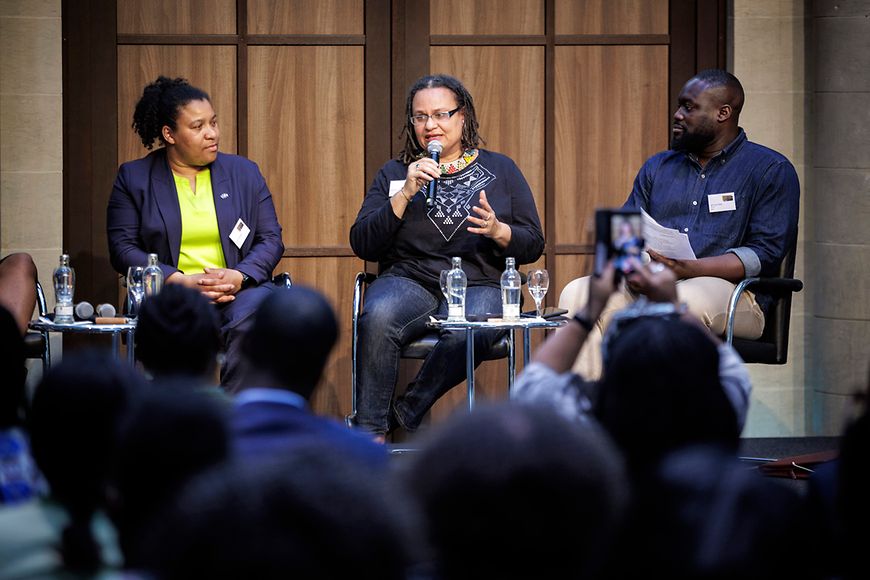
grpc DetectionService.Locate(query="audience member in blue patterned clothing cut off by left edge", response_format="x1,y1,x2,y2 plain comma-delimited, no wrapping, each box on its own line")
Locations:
0,306,45,506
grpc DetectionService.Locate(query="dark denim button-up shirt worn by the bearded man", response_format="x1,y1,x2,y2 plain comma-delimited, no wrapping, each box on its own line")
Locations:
624,129,800,277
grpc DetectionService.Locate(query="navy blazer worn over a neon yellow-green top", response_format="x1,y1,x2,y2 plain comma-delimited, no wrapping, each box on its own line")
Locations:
106,148,284,284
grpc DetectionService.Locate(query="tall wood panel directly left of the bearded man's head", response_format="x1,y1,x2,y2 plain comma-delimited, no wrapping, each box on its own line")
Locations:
554,46,669,244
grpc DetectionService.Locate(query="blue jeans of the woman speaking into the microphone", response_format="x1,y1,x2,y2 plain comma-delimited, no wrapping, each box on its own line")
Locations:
357,274,504,433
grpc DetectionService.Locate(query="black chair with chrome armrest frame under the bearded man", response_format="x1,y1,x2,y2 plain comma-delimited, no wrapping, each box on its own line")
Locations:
725,248,804,365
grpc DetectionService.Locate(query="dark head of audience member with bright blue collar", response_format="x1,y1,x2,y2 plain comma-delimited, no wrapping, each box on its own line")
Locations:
243,285,338,399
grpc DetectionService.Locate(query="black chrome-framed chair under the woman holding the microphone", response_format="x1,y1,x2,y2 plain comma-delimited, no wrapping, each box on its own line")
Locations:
345,272,513,427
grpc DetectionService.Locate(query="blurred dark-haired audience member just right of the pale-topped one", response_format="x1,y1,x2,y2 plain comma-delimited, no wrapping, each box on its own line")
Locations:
110,383,229,569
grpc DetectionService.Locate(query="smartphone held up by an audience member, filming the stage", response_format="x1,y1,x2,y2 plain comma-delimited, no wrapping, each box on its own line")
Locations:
595,209,644,278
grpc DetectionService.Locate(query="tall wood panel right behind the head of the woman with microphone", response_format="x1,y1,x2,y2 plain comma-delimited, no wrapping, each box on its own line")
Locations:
430,46,546,233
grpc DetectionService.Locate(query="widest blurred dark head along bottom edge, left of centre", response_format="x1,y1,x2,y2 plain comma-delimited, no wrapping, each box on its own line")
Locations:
144,446,414,580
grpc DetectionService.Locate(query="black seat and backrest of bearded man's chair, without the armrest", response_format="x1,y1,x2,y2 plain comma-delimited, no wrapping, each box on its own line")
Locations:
733,248,795,365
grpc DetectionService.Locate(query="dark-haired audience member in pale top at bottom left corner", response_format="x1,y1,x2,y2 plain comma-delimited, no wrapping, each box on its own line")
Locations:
0,352,143,578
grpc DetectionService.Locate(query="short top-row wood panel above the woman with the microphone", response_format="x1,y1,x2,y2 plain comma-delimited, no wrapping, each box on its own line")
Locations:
429,0,544,34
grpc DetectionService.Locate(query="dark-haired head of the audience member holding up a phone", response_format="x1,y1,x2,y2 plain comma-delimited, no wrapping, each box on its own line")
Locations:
596,316,739,474
